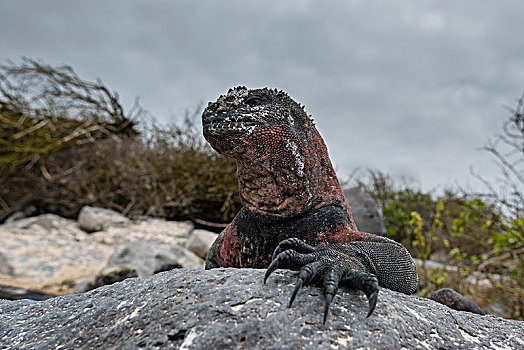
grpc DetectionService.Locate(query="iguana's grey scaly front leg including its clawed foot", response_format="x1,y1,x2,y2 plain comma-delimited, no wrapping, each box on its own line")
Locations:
264,236,418,323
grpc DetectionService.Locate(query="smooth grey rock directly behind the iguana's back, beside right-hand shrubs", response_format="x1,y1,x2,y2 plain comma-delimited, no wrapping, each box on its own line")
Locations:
344,186,386,236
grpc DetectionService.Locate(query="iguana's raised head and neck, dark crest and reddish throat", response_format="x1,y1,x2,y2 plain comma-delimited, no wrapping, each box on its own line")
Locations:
202,87,345,217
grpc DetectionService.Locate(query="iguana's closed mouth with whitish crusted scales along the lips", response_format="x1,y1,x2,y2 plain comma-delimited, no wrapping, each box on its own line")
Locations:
202,114,264,135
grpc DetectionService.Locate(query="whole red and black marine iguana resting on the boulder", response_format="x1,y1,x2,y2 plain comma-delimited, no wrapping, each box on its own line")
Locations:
202,86,418,323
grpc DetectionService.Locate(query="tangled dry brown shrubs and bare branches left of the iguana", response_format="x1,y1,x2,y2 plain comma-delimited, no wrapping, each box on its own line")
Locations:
0,59,240,222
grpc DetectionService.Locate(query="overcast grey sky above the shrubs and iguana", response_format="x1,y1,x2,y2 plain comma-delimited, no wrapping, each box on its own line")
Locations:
0,0,524,189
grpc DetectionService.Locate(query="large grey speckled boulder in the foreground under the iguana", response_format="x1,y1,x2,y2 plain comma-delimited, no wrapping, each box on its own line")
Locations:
0,269,524,349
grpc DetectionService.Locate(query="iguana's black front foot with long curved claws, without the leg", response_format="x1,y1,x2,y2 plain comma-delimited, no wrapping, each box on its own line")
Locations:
264,238,379,324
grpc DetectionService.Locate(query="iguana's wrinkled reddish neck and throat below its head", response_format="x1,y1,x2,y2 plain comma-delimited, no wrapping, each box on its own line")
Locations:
237,125,351,219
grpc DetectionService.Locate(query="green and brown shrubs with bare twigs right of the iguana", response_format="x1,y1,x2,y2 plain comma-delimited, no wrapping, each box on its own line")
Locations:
359,96,524,320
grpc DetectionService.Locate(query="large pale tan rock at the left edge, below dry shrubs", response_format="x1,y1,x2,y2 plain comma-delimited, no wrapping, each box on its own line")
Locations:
0,214,113,294
